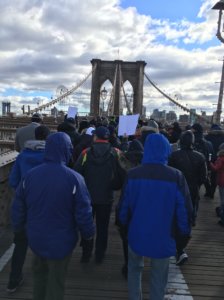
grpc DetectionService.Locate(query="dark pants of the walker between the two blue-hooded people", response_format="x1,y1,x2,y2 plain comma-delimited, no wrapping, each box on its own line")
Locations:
93,203,112,257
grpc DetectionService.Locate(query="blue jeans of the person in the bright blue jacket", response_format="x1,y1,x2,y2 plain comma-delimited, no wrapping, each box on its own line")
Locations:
128,246,169,300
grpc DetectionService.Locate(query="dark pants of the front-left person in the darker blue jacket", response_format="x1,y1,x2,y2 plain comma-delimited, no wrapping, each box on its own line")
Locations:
33,254,71,300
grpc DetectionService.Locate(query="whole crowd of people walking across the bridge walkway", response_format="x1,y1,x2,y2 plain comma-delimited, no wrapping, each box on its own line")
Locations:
7,113,224,300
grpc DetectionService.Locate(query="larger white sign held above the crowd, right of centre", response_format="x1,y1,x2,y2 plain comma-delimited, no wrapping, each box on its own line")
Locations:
118,114,139,136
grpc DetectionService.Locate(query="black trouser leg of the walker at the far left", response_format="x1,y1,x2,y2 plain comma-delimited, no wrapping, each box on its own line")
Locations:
9,231,28,282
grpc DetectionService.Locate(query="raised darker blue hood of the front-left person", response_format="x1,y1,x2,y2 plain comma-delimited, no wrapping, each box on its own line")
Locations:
44,132,73,165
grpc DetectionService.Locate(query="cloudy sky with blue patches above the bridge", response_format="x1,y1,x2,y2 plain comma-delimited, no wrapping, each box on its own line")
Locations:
0,0,224,114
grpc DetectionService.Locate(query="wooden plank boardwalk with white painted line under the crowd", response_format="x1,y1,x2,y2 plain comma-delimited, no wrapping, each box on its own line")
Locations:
0,189,224,300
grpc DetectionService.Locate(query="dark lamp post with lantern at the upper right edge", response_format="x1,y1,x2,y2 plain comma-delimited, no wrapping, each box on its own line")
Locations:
212,0,224,124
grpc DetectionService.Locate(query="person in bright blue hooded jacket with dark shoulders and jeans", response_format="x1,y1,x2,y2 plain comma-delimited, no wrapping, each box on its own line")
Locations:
119,133,192,300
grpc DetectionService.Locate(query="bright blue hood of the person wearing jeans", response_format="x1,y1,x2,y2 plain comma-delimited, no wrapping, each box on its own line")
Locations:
142,133,171,164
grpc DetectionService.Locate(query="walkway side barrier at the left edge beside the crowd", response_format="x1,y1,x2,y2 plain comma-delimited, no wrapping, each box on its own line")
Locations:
0,151,18,229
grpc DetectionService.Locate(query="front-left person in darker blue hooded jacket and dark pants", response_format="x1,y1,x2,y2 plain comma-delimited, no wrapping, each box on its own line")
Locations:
12,132,95,300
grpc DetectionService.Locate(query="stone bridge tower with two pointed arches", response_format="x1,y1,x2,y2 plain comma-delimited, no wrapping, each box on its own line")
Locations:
90,59,146,116
